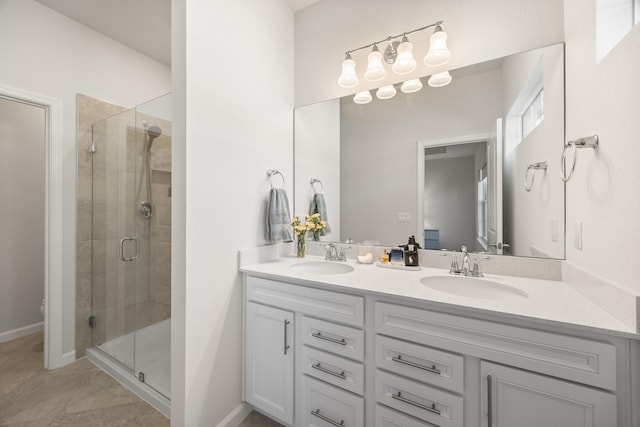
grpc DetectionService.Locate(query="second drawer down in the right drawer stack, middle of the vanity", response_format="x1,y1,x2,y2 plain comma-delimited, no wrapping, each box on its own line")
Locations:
375,370,464,427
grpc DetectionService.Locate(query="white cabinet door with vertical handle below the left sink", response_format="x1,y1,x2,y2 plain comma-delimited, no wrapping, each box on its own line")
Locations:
245,302,294,425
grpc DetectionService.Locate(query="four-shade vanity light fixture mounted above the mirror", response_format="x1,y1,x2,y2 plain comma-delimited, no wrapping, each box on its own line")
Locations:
338,21,451,89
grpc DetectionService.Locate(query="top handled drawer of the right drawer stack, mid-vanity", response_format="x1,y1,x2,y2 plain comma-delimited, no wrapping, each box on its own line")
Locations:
376,335,464,394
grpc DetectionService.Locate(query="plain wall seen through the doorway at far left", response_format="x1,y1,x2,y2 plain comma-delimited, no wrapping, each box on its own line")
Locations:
0,98,46,342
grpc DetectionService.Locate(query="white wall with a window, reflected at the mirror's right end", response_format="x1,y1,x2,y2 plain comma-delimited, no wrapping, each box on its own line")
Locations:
502,45,565,258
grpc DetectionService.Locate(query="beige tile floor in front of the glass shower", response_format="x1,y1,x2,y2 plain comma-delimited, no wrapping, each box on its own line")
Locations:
0,333,169,427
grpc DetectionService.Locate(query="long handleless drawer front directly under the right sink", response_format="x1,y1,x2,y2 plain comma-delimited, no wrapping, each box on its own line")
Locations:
375,302,616,390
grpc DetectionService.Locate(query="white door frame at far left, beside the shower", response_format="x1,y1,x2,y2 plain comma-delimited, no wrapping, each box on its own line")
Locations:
0,86,69,369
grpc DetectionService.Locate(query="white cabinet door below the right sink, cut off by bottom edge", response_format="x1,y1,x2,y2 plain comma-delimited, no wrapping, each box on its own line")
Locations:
481,362,618,427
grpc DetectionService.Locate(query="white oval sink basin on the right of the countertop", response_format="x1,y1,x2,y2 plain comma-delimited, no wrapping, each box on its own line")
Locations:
420,276,529,300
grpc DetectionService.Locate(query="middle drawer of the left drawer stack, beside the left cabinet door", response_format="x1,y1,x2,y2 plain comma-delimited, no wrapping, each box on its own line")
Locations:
302,346,364,395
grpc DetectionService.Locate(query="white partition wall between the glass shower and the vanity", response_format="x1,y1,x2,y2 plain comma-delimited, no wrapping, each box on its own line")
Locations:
172,0,293,427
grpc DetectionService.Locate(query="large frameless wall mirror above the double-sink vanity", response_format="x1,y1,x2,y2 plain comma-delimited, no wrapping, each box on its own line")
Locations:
294,44,565,259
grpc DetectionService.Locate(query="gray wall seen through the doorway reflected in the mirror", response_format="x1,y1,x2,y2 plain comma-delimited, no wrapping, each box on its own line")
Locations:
420,157,477,250
